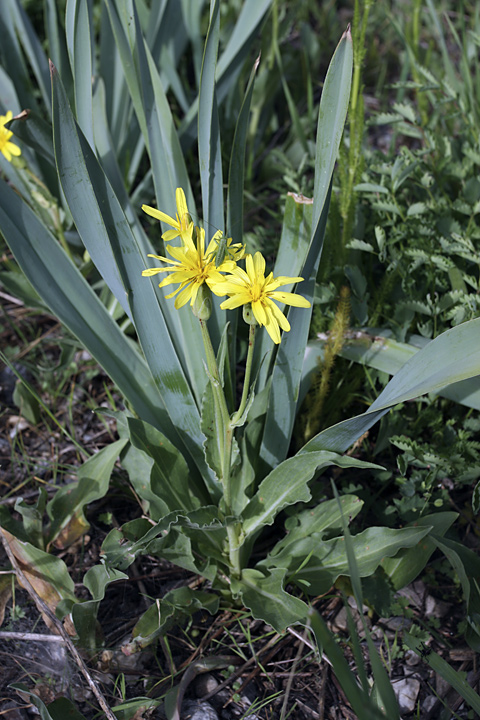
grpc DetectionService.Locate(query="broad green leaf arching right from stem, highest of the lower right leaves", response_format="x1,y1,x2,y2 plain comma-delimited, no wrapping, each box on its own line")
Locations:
242,452,378,536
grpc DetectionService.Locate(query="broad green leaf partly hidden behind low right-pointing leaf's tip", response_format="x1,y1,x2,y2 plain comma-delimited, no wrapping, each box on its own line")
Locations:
381,512,458,590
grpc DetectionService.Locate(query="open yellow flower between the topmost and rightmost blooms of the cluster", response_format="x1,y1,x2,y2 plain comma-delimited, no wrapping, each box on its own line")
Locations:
142,227,235,309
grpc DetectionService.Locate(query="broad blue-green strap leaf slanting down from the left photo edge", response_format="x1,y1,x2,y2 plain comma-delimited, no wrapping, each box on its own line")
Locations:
0,180,171,440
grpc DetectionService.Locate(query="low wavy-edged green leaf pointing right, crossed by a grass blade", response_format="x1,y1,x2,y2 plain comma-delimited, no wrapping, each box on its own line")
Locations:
289,526,431,595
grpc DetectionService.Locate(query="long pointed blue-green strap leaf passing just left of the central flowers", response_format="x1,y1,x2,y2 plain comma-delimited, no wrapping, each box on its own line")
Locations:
52,59,214,486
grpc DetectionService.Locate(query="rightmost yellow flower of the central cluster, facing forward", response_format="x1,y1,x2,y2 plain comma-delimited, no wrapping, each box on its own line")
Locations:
210,252,310,344
